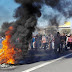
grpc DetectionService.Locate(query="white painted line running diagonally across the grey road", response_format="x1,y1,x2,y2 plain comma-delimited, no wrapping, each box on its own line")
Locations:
22,53,72,72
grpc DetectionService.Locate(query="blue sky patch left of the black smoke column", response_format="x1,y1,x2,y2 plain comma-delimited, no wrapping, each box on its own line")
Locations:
0,0,19,27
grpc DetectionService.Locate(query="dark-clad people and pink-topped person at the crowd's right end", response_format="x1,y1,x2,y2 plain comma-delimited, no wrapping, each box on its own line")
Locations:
54,32,72,52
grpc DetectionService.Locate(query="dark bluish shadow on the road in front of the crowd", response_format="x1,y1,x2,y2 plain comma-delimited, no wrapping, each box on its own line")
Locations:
16,49,71,65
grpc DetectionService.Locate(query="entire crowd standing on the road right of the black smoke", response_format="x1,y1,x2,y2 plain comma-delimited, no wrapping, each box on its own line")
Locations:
29,32,72,52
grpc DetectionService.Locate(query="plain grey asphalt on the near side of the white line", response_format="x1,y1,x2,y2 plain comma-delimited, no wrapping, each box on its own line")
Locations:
32,56,72,72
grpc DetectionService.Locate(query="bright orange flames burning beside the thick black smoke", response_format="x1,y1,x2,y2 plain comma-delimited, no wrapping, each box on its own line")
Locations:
0,26,21,64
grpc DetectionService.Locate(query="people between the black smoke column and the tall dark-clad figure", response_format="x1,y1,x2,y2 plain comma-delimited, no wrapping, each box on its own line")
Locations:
29,34,54,50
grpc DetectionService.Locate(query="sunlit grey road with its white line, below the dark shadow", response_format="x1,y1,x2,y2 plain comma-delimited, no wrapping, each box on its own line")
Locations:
0,49,72,72
